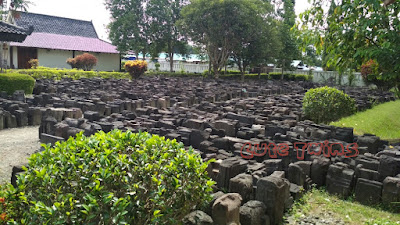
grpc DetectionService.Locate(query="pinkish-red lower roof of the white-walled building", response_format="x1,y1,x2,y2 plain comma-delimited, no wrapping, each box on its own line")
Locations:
10,33,119,54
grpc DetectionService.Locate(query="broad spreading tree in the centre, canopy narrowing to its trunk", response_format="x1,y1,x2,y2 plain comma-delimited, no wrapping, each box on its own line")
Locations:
179,0,270,78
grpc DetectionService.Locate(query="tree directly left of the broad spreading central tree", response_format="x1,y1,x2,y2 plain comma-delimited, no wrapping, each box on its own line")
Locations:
146,0,188,72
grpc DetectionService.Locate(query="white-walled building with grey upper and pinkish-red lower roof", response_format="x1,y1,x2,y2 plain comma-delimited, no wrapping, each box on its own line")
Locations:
8,12,121,71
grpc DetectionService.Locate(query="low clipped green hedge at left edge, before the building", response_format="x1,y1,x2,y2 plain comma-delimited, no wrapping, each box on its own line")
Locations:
0,73,35,95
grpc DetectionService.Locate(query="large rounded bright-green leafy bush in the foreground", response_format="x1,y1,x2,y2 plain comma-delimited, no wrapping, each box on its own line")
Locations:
9,130,214,225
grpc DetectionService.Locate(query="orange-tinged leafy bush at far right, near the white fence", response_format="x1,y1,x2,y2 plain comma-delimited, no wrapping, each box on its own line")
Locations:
361,59,396,90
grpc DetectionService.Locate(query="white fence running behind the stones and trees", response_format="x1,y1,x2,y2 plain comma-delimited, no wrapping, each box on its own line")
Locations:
148,62,366,87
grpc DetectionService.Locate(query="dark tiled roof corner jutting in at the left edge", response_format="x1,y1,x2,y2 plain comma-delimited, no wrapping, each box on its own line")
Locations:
0,21,32,42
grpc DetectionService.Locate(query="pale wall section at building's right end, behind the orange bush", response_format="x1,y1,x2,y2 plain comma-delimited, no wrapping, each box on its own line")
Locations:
75,52,120,71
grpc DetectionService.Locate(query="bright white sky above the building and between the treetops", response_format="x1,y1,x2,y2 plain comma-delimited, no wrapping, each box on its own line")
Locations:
24,0,309,40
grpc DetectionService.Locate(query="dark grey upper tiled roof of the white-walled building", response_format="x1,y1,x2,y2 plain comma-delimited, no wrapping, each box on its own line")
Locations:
15,12,98,38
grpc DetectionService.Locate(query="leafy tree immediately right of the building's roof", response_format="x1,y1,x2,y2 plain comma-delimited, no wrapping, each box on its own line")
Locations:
106,0,150,58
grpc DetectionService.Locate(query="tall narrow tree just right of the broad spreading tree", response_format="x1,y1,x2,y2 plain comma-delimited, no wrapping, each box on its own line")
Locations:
278,0,300,79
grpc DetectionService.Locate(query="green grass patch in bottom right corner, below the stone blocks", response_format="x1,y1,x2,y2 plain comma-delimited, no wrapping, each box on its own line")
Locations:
287,189,400,225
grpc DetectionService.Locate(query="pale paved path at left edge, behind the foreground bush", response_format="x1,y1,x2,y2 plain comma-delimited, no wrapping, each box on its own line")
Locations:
0,126,40,184
